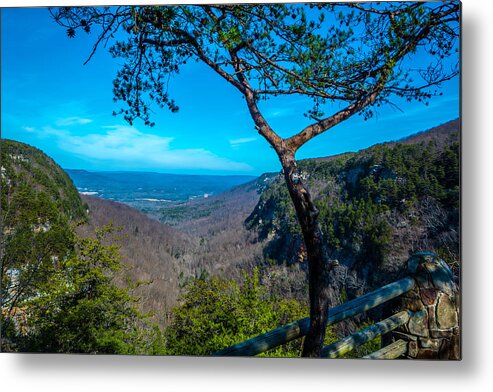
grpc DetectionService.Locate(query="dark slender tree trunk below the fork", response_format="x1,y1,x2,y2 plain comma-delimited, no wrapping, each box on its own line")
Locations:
280,153,330,357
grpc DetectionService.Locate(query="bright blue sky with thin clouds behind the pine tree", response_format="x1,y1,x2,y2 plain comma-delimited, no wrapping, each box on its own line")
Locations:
1,8,459,175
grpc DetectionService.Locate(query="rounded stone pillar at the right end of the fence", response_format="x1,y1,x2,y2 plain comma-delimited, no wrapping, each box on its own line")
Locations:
392,253,461,360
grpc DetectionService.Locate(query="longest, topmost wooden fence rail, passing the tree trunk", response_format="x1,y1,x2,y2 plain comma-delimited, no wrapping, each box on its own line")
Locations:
212,277,415,356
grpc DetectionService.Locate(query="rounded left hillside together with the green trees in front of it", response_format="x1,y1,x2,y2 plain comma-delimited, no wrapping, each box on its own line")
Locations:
0,140,160,353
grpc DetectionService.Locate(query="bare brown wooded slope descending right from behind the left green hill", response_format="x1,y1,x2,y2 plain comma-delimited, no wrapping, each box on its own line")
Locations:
77,195,192,325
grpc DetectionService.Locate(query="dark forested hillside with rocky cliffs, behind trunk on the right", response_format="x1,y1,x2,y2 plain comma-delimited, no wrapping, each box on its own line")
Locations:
246,120,460,296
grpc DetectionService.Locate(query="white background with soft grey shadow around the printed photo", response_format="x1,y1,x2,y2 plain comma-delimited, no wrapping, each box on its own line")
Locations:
0,0,493,392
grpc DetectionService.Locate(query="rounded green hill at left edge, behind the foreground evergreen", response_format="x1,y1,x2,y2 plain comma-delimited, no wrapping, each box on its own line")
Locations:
0,140,85,349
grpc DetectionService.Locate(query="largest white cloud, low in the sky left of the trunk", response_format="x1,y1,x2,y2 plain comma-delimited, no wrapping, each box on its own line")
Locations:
50,125,252,171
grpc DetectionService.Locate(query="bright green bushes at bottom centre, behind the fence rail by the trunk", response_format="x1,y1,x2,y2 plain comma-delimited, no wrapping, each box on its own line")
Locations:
166,269,333,357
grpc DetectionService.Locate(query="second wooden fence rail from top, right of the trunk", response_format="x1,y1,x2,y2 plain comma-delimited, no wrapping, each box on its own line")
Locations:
321,310,410,358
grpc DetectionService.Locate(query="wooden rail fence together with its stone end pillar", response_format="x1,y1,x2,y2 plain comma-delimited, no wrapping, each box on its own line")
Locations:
212,253,460,359
